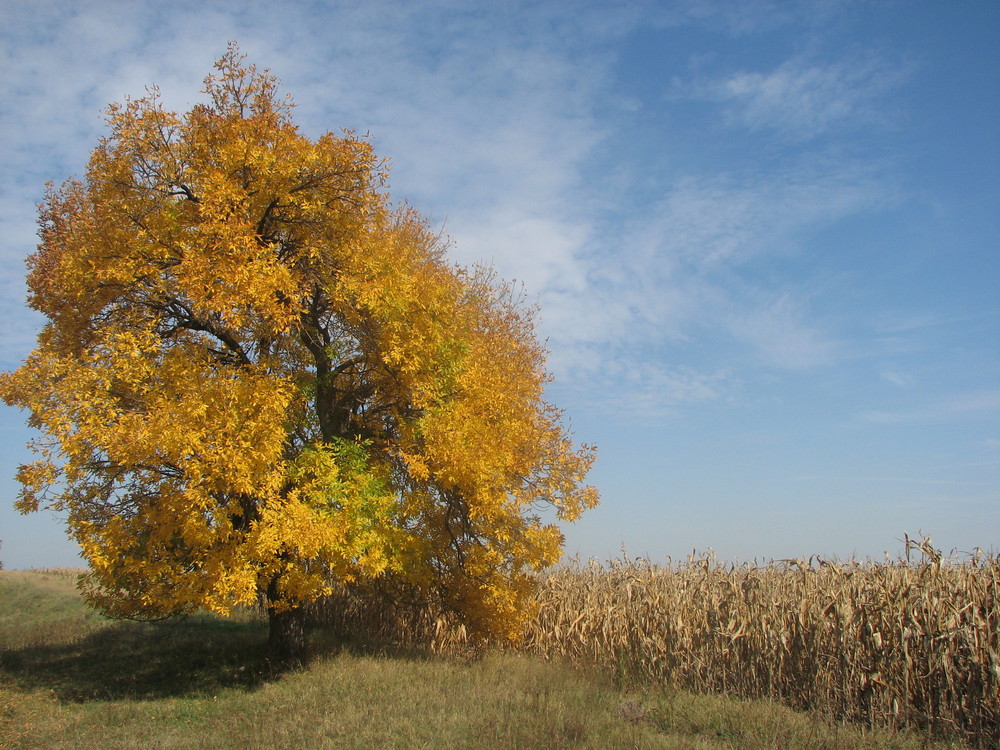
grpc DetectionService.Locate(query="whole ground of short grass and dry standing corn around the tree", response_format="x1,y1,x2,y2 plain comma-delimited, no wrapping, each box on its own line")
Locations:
0,544,1000,750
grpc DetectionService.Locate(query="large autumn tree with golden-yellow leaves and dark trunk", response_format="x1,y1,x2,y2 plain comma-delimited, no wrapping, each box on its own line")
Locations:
0,45,597,660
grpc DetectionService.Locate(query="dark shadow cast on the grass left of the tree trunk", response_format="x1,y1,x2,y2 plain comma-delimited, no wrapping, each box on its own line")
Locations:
0,614,281,702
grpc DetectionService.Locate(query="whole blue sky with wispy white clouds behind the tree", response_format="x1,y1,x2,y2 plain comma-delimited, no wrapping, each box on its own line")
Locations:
0,0,1000,569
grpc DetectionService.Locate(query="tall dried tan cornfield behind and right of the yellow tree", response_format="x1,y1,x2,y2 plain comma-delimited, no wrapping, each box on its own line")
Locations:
316,538,1000,748
